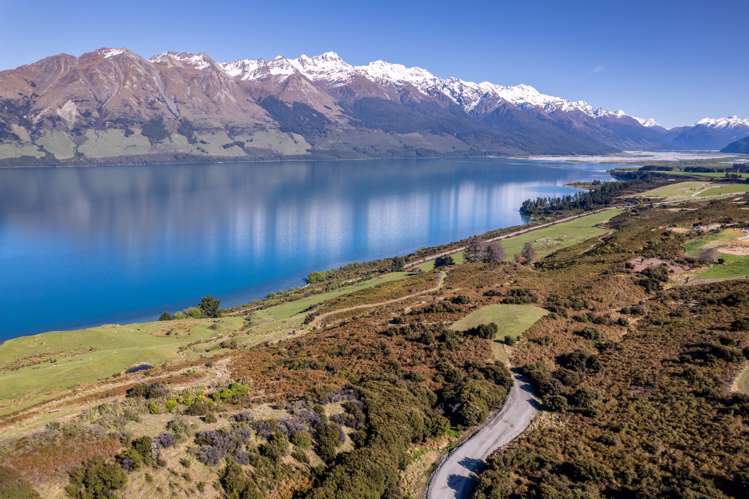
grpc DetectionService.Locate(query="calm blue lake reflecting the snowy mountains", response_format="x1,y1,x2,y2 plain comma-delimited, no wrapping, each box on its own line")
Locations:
0,159,611,341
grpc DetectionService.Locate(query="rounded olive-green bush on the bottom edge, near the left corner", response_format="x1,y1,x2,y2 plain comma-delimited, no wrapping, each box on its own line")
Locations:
65,457,127,499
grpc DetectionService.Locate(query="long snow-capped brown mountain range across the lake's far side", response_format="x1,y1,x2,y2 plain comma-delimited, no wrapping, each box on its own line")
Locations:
0,48,749,164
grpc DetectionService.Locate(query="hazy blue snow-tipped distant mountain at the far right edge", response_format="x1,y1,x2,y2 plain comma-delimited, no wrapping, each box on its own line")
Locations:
666,116,749,150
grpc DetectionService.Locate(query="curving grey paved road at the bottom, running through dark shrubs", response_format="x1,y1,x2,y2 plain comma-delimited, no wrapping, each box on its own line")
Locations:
426,374,538,499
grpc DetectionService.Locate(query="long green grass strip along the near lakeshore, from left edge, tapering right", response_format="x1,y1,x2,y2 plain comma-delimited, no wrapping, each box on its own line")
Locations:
0,272,408,415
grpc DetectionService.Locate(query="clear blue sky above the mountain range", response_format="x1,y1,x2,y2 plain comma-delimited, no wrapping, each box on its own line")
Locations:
0,0,749,126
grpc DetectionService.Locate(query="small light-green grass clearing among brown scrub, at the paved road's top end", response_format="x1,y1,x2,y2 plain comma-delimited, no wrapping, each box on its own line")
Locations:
450,305,549,362
